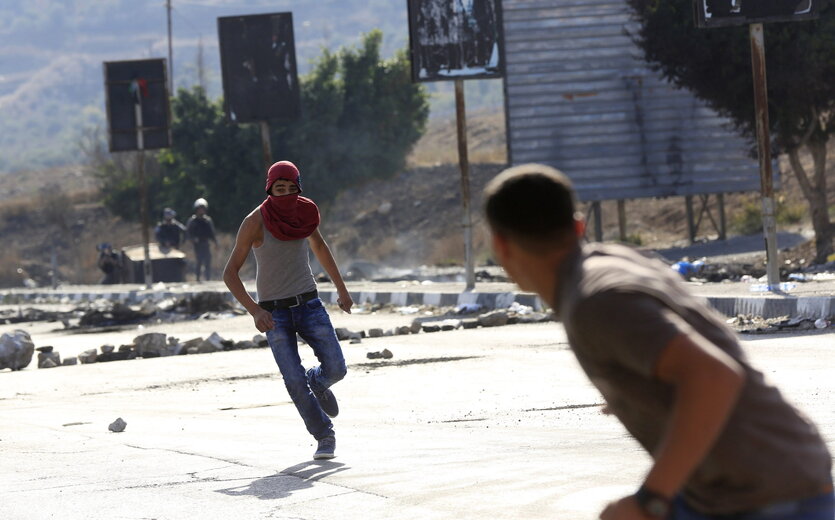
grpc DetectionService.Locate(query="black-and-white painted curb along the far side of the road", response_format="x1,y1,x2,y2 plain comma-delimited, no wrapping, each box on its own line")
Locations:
0,290,835,320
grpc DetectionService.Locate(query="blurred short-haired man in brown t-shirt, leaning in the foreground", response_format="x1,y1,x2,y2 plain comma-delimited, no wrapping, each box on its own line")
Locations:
485,164,833,520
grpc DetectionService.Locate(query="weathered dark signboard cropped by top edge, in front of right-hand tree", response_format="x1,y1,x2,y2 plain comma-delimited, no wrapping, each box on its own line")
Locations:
693,0,820,27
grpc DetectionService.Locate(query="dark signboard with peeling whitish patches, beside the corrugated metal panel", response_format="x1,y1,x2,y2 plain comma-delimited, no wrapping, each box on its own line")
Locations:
408,0,504,81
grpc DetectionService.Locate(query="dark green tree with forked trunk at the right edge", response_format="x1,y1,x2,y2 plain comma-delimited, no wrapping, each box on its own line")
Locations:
627,0,835,262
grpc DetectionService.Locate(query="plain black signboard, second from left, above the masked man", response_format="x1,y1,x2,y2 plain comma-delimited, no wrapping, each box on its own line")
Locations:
217,13,299,123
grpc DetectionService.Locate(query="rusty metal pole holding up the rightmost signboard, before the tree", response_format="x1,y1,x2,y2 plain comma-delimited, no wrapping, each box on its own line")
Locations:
748,23,780,291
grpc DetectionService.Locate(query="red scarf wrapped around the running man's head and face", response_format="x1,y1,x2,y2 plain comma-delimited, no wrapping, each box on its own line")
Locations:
261,161,319,240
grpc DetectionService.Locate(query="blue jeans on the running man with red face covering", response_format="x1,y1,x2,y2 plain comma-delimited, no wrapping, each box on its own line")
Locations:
267,298,347,440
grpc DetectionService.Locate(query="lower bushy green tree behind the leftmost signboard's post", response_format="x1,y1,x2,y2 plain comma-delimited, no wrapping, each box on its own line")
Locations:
90,87,263,231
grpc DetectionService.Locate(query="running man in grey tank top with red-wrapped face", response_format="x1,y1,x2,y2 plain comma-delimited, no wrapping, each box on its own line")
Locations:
223,161,353,459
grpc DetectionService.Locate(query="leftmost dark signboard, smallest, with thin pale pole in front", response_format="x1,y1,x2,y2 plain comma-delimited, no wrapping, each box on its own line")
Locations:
104,58,171,152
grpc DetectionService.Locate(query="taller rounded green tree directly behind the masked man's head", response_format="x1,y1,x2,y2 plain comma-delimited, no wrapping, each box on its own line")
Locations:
273,31,429,203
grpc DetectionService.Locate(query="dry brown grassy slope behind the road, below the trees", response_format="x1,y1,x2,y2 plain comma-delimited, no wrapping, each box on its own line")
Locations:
0,114,835,287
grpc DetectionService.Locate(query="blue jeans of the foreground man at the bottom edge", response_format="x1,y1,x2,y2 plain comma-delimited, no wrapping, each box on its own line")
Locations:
671,493,835,520
